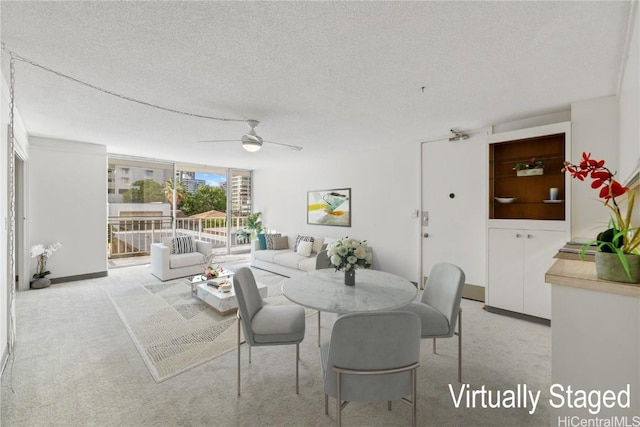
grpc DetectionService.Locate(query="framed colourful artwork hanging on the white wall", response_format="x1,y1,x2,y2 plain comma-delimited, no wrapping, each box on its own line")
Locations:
307,188,351,227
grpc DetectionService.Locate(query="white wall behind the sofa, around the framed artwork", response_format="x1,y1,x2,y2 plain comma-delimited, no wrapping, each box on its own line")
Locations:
254,143,420,281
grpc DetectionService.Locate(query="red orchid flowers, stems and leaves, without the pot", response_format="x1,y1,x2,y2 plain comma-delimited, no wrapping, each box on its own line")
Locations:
562,153,640,278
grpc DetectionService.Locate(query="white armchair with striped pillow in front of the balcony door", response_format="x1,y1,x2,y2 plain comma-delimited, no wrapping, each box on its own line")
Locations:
151,236,212,282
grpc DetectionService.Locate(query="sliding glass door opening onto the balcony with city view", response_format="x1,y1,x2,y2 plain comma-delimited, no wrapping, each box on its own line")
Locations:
107,155,252,266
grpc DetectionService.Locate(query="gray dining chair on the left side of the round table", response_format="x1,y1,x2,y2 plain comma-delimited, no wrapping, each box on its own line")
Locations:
233,267,305,396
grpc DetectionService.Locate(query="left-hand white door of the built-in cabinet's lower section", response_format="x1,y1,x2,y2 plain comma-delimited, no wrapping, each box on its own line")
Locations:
487,228,525,313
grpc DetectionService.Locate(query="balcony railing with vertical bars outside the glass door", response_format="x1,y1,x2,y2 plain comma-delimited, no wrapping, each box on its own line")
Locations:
107,216,249,258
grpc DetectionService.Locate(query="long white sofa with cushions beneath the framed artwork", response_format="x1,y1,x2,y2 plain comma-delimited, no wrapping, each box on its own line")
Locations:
251,233,337,277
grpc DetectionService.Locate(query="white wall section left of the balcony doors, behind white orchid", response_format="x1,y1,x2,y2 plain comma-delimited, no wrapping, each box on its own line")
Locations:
28,137,107,279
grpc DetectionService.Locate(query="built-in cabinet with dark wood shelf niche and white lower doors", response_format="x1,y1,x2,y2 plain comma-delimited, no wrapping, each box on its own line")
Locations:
486,123,571,319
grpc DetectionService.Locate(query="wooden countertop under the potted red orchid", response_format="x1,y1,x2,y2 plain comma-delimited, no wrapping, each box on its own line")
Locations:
544,259,640,298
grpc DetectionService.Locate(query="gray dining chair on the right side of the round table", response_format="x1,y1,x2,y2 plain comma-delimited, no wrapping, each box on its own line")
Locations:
399,262,465,382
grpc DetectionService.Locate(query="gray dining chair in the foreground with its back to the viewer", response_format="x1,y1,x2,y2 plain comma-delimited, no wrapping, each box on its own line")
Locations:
320,311,421,426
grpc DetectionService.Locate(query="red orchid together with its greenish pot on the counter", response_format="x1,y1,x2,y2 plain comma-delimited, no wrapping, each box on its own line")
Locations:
563,153,640,283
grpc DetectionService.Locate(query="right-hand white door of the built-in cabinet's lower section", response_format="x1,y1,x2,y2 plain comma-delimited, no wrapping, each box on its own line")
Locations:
523,230,566,319
